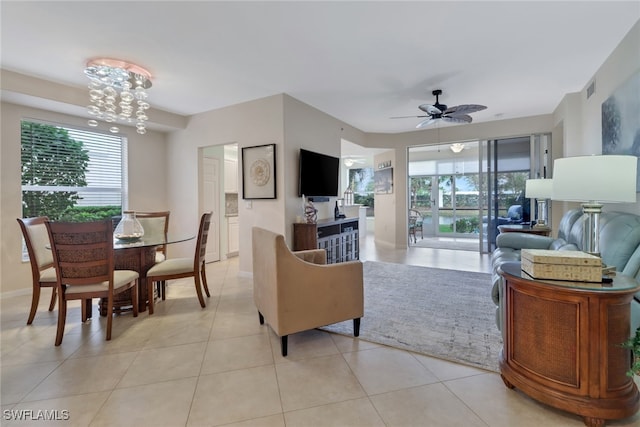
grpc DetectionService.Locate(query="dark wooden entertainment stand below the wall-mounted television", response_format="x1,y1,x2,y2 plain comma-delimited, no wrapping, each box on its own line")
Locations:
293,218,360,264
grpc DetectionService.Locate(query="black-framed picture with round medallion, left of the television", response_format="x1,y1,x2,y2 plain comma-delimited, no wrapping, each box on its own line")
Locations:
242,144,277,200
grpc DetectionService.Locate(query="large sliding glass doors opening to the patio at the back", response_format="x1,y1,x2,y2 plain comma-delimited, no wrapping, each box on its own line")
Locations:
408,134,551,252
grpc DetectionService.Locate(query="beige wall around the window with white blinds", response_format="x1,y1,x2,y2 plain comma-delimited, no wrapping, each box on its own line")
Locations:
0,102,169,294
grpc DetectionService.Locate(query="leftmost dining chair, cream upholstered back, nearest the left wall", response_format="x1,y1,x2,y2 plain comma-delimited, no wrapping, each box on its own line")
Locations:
17,216,56,325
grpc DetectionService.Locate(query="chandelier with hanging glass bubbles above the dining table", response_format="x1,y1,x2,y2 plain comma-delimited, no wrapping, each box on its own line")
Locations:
84,58,151,135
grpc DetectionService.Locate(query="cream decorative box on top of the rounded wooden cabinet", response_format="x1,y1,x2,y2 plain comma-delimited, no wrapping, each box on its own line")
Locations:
520,249,602,282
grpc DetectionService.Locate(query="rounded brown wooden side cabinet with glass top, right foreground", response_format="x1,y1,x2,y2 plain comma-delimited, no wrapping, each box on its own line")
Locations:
499,263,640,427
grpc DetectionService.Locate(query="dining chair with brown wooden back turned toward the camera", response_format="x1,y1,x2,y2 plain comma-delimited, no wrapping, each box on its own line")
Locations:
45,220,138,346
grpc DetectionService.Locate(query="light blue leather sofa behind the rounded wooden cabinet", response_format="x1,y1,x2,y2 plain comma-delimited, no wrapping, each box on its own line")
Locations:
491,209,640,333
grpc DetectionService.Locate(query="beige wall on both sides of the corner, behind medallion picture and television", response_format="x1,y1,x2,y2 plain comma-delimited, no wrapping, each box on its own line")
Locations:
167,94,362,272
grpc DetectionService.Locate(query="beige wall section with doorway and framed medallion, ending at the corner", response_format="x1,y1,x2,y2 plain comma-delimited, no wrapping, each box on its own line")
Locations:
167,95,285,271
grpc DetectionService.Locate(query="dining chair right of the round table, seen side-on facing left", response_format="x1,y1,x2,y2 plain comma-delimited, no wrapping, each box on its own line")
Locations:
147,212,212,315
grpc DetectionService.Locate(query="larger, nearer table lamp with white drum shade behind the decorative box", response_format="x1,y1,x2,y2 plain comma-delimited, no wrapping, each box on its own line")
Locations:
551,155,638,256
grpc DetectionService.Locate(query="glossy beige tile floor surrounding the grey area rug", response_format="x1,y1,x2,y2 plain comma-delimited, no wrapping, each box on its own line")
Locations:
0,232,640,427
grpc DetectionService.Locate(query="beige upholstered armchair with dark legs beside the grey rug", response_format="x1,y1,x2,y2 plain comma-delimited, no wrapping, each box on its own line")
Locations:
252,227,364,356
